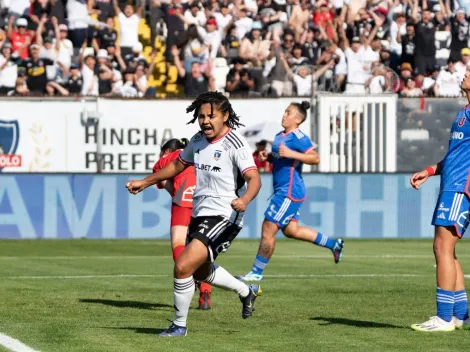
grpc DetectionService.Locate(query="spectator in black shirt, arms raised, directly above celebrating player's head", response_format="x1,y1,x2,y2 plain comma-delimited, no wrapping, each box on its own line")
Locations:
171,46,214,97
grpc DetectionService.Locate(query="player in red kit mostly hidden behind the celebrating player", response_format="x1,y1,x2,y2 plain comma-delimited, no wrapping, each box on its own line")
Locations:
153,138,212,310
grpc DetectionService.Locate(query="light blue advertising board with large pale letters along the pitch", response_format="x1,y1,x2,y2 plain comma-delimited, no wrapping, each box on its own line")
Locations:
0,174,439,239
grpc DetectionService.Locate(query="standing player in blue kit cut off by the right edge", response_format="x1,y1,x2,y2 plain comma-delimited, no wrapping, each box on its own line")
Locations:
410,72,470,332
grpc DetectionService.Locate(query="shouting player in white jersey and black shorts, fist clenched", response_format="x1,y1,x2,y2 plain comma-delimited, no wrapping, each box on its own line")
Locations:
126,92,261,337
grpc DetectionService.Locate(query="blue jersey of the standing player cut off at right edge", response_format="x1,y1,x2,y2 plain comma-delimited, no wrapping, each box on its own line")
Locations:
441,104,470,197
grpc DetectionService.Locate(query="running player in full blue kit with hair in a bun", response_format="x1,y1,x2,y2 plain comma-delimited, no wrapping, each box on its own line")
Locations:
239,101,343,281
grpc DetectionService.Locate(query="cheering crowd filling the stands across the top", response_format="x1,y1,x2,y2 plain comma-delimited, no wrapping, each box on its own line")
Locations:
0,0,470,97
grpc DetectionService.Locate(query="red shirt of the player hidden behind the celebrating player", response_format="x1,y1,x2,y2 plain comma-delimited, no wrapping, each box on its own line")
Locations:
153,150,196,208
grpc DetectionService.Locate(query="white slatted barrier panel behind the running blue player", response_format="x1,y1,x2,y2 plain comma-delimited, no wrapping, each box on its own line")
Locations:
315,93,397,173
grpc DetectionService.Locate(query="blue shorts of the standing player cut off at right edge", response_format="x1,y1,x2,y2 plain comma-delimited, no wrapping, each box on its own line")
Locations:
432,191,470,237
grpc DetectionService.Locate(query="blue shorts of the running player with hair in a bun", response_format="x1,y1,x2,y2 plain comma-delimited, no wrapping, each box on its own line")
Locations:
264,194,303,229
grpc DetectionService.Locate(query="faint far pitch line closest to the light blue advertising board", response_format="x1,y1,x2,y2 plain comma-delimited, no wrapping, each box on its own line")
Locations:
0,254,464,260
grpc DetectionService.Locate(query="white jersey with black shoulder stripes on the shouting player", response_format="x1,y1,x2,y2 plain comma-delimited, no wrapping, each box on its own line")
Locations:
179,129,257,226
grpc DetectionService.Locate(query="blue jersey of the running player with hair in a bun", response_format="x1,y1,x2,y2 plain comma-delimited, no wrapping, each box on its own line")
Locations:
271,129,316,202
